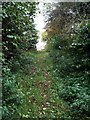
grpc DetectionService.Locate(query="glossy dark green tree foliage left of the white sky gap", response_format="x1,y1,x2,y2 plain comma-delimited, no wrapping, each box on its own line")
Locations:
2,2,37,59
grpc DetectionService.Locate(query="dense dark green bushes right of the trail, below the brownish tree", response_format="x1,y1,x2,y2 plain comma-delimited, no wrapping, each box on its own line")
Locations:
51,20,90,120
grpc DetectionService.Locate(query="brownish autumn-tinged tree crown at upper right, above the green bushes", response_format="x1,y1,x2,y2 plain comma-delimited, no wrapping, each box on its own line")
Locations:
46,2,89,36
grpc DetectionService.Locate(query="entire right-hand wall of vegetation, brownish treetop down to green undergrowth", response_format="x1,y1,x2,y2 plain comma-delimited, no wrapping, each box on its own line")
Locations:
46,2,90,120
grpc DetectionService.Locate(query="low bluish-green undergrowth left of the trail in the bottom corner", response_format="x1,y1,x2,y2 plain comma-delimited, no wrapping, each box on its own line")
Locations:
2,65,23,120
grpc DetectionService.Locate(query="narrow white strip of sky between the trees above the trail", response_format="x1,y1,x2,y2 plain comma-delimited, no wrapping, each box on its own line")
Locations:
35,2,46,50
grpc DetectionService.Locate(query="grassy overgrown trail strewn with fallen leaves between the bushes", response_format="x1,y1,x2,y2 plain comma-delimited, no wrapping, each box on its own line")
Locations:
17,51,64,118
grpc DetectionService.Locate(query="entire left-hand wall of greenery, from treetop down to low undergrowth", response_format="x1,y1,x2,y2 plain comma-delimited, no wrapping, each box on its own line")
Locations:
2,2,37,120
